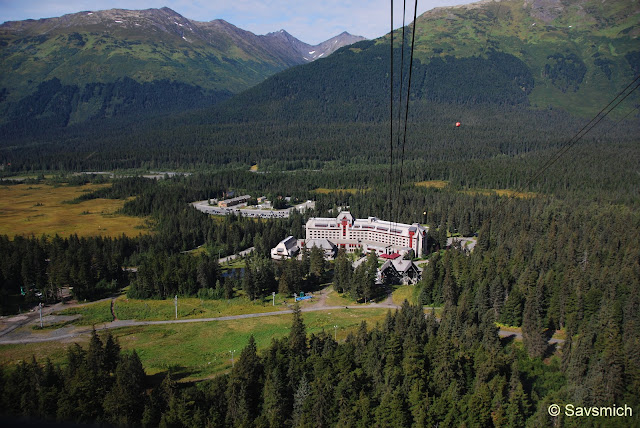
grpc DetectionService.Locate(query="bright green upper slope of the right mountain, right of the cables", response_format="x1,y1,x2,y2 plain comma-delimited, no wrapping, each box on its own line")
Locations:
416,0,640,114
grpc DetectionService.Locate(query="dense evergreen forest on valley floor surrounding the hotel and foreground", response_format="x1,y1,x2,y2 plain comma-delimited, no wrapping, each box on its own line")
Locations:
0,164,640,426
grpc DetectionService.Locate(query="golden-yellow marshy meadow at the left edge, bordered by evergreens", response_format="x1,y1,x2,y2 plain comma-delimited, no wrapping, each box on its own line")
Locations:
0,184,148,236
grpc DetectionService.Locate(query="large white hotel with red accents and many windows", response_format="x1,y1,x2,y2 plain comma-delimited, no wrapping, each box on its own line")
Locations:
306,211,427,257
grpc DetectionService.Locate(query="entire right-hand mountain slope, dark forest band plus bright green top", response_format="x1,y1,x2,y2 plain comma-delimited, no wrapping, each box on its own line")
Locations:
220,0,640,120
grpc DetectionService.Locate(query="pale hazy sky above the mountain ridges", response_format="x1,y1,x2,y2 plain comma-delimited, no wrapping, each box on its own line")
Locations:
0,0,472,44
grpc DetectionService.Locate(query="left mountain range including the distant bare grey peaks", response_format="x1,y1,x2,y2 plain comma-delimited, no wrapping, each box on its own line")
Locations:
0,8,364,127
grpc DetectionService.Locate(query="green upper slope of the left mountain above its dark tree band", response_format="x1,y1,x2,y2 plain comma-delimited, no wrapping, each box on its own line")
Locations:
0,8,288,95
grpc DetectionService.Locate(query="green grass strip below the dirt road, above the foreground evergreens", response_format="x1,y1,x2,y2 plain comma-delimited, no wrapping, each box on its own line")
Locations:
0,302,387,380
